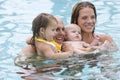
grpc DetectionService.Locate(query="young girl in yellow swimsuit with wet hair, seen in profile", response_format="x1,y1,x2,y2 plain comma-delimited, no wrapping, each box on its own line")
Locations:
31,13,73,59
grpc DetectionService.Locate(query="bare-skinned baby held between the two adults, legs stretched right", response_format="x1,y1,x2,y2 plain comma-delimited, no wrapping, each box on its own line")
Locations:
62,24,108,53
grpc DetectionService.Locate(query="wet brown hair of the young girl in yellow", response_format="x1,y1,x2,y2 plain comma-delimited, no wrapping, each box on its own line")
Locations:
31,13,57,45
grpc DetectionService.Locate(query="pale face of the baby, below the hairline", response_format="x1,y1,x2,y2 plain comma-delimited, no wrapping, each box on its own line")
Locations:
66,26,81,41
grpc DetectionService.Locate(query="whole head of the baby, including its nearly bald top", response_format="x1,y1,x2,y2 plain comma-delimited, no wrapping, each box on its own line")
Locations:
65,24,82,41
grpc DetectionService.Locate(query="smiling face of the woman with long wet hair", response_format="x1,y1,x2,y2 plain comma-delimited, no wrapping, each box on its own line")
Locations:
78,7,96,33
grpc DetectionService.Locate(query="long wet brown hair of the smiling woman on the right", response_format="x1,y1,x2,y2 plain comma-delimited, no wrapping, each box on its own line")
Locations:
71,1,97,33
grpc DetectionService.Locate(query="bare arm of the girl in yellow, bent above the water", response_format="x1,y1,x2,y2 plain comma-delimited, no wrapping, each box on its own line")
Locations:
36,42,73,59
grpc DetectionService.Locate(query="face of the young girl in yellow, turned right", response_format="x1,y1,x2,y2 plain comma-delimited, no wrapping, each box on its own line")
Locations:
44,21,57,41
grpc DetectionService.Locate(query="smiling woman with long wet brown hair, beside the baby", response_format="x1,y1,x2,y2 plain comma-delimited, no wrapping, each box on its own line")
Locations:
71,2,117,51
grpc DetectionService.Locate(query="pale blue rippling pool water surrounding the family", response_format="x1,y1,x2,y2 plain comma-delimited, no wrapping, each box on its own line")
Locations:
0,0,120,80
